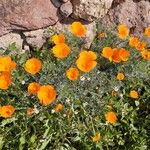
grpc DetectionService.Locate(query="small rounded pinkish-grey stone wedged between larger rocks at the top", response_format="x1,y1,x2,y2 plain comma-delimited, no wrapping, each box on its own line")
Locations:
60,1,73,18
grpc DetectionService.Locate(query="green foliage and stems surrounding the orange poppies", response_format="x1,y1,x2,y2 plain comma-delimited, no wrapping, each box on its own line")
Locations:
0,24,150,150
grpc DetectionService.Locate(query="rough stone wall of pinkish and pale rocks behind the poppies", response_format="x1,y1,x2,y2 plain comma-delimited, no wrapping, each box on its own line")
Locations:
0,0,150,49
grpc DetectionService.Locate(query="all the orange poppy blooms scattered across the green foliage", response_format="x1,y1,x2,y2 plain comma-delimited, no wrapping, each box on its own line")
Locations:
0,22,150,122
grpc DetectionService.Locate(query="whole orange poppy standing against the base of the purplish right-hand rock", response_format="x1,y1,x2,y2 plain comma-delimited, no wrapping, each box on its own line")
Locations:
118,24,129,39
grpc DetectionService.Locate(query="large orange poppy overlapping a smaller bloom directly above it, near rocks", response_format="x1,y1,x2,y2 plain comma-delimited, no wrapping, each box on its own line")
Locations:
52,43,70,59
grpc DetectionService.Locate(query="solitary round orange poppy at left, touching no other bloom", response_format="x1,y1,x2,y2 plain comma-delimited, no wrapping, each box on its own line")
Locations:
24,58,42,75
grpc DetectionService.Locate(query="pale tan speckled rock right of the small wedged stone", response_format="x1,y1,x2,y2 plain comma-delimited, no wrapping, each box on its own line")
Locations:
72,0,113,22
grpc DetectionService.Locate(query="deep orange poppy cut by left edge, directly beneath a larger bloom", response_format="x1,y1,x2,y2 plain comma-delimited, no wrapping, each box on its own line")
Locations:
0,72,12,90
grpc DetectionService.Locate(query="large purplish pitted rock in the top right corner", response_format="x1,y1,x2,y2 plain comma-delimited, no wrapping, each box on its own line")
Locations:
102,0,150,36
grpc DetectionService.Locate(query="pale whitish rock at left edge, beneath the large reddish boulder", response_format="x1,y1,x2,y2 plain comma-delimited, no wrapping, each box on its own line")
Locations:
0,33,23,49
